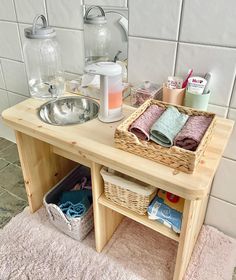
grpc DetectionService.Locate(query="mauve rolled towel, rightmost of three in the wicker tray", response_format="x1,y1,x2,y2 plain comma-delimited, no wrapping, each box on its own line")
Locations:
174,116,212,151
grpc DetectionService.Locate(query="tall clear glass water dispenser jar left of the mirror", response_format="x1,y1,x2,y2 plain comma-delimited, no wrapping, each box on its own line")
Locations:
23,15,65,99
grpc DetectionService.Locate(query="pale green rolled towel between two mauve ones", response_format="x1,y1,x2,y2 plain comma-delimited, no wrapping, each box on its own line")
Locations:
150,106,188,147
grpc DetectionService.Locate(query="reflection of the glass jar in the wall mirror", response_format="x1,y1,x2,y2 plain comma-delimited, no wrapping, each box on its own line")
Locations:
84,6,111,64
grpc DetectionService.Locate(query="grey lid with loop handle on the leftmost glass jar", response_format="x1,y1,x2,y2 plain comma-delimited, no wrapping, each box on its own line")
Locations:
24,15,56,39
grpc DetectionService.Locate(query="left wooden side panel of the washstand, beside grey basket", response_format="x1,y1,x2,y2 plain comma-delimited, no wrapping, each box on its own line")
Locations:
15,131,76,212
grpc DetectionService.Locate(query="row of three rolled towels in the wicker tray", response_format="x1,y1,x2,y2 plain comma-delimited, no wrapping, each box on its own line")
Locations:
129,105,212,151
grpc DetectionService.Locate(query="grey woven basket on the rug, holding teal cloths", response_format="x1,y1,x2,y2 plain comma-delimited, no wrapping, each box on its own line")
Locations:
43,166,93,241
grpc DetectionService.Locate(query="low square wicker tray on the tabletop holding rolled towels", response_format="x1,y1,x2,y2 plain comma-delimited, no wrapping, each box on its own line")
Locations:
114,99,216,173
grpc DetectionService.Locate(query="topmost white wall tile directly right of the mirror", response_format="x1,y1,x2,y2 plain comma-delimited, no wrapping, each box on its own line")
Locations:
129,0,182,40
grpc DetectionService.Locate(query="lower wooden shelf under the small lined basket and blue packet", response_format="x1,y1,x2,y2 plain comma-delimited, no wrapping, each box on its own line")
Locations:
98,193,179,242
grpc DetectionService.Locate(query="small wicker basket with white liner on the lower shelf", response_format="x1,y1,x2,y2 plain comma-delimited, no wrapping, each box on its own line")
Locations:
101,167,157,215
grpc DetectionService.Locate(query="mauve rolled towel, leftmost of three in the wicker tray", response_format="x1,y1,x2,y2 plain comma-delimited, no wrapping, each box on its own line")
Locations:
129,105,165,141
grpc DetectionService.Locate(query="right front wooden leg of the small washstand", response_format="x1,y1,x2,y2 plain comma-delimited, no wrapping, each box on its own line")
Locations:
173,196,208,280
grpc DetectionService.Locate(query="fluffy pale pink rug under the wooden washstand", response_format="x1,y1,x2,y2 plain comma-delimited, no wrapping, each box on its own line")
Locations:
0,208,236,280
